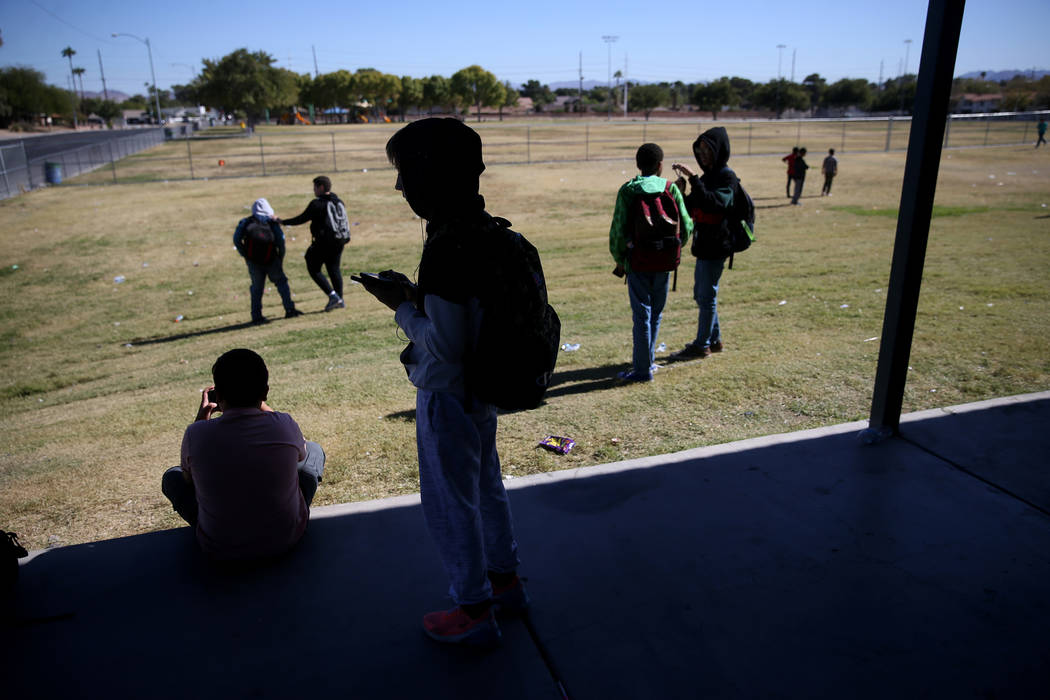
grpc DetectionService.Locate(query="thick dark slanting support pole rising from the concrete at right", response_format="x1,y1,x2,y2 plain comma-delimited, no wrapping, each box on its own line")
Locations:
865,0,963,441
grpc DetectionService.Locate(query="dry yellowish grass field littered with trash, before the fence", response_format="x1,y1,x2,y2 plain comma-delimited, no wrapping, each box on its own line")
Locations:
0,125,1050,548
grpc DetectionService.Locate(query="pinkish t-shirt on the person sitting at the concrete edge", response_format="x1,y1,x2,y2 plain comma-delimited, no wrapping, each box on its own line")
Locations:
182,408,310,559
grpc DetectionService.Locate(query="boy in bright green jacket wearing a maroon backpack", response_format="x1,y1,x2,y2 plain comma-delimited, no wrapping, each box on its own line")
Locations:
609,144,693,382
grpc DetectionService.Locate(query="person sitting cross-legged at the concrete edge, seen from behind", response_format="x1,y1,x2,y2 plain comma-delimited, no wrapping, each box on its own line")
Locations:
161,348,324,561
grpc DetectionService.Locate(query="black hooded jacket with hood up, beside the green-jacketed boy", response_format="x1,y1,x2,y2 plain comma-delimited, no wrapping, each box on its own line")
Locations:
686,126,740,260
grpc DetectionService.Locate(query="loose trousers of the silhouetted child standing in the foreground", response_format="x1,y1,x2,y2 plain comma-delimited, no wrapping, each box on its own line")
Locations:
416,389,518,604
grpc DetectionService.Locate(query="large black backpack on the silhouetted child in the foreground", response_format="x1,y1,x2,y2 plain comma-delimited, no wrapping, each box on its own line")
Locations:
465,215,562,410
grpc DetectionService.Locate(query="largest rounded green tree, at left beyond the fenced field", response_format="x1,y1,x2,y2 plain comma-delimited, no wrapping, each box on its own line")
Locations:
200,48,298,122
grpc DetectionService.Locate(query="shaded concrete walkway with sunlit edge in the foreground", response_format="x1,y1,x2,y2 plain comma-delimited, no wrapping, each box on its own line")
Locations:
2,393,1050,700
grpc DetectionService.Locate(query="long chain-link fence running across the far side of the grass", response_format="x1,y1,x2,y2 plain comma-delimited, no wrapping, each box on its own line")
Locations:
3,110,1050,196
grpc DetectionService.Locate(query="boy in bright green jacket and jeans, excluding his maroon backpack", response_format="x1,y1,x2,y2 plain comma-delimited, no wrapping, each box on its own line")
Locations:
609,144,693,382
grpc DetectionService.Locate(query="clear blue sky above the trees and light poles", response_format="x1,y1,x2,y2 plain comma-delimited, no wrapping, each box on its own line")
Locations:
0,0,1050,98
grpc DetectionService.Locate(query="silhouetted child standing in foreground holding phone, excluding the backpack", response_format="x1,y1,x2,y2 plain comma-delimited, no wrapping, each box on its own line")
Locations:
354,119,528,645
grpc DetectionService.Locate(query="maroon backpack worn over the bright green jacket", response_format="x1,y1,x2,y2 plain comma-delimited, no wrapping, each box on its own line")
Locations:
628,182,681,272
